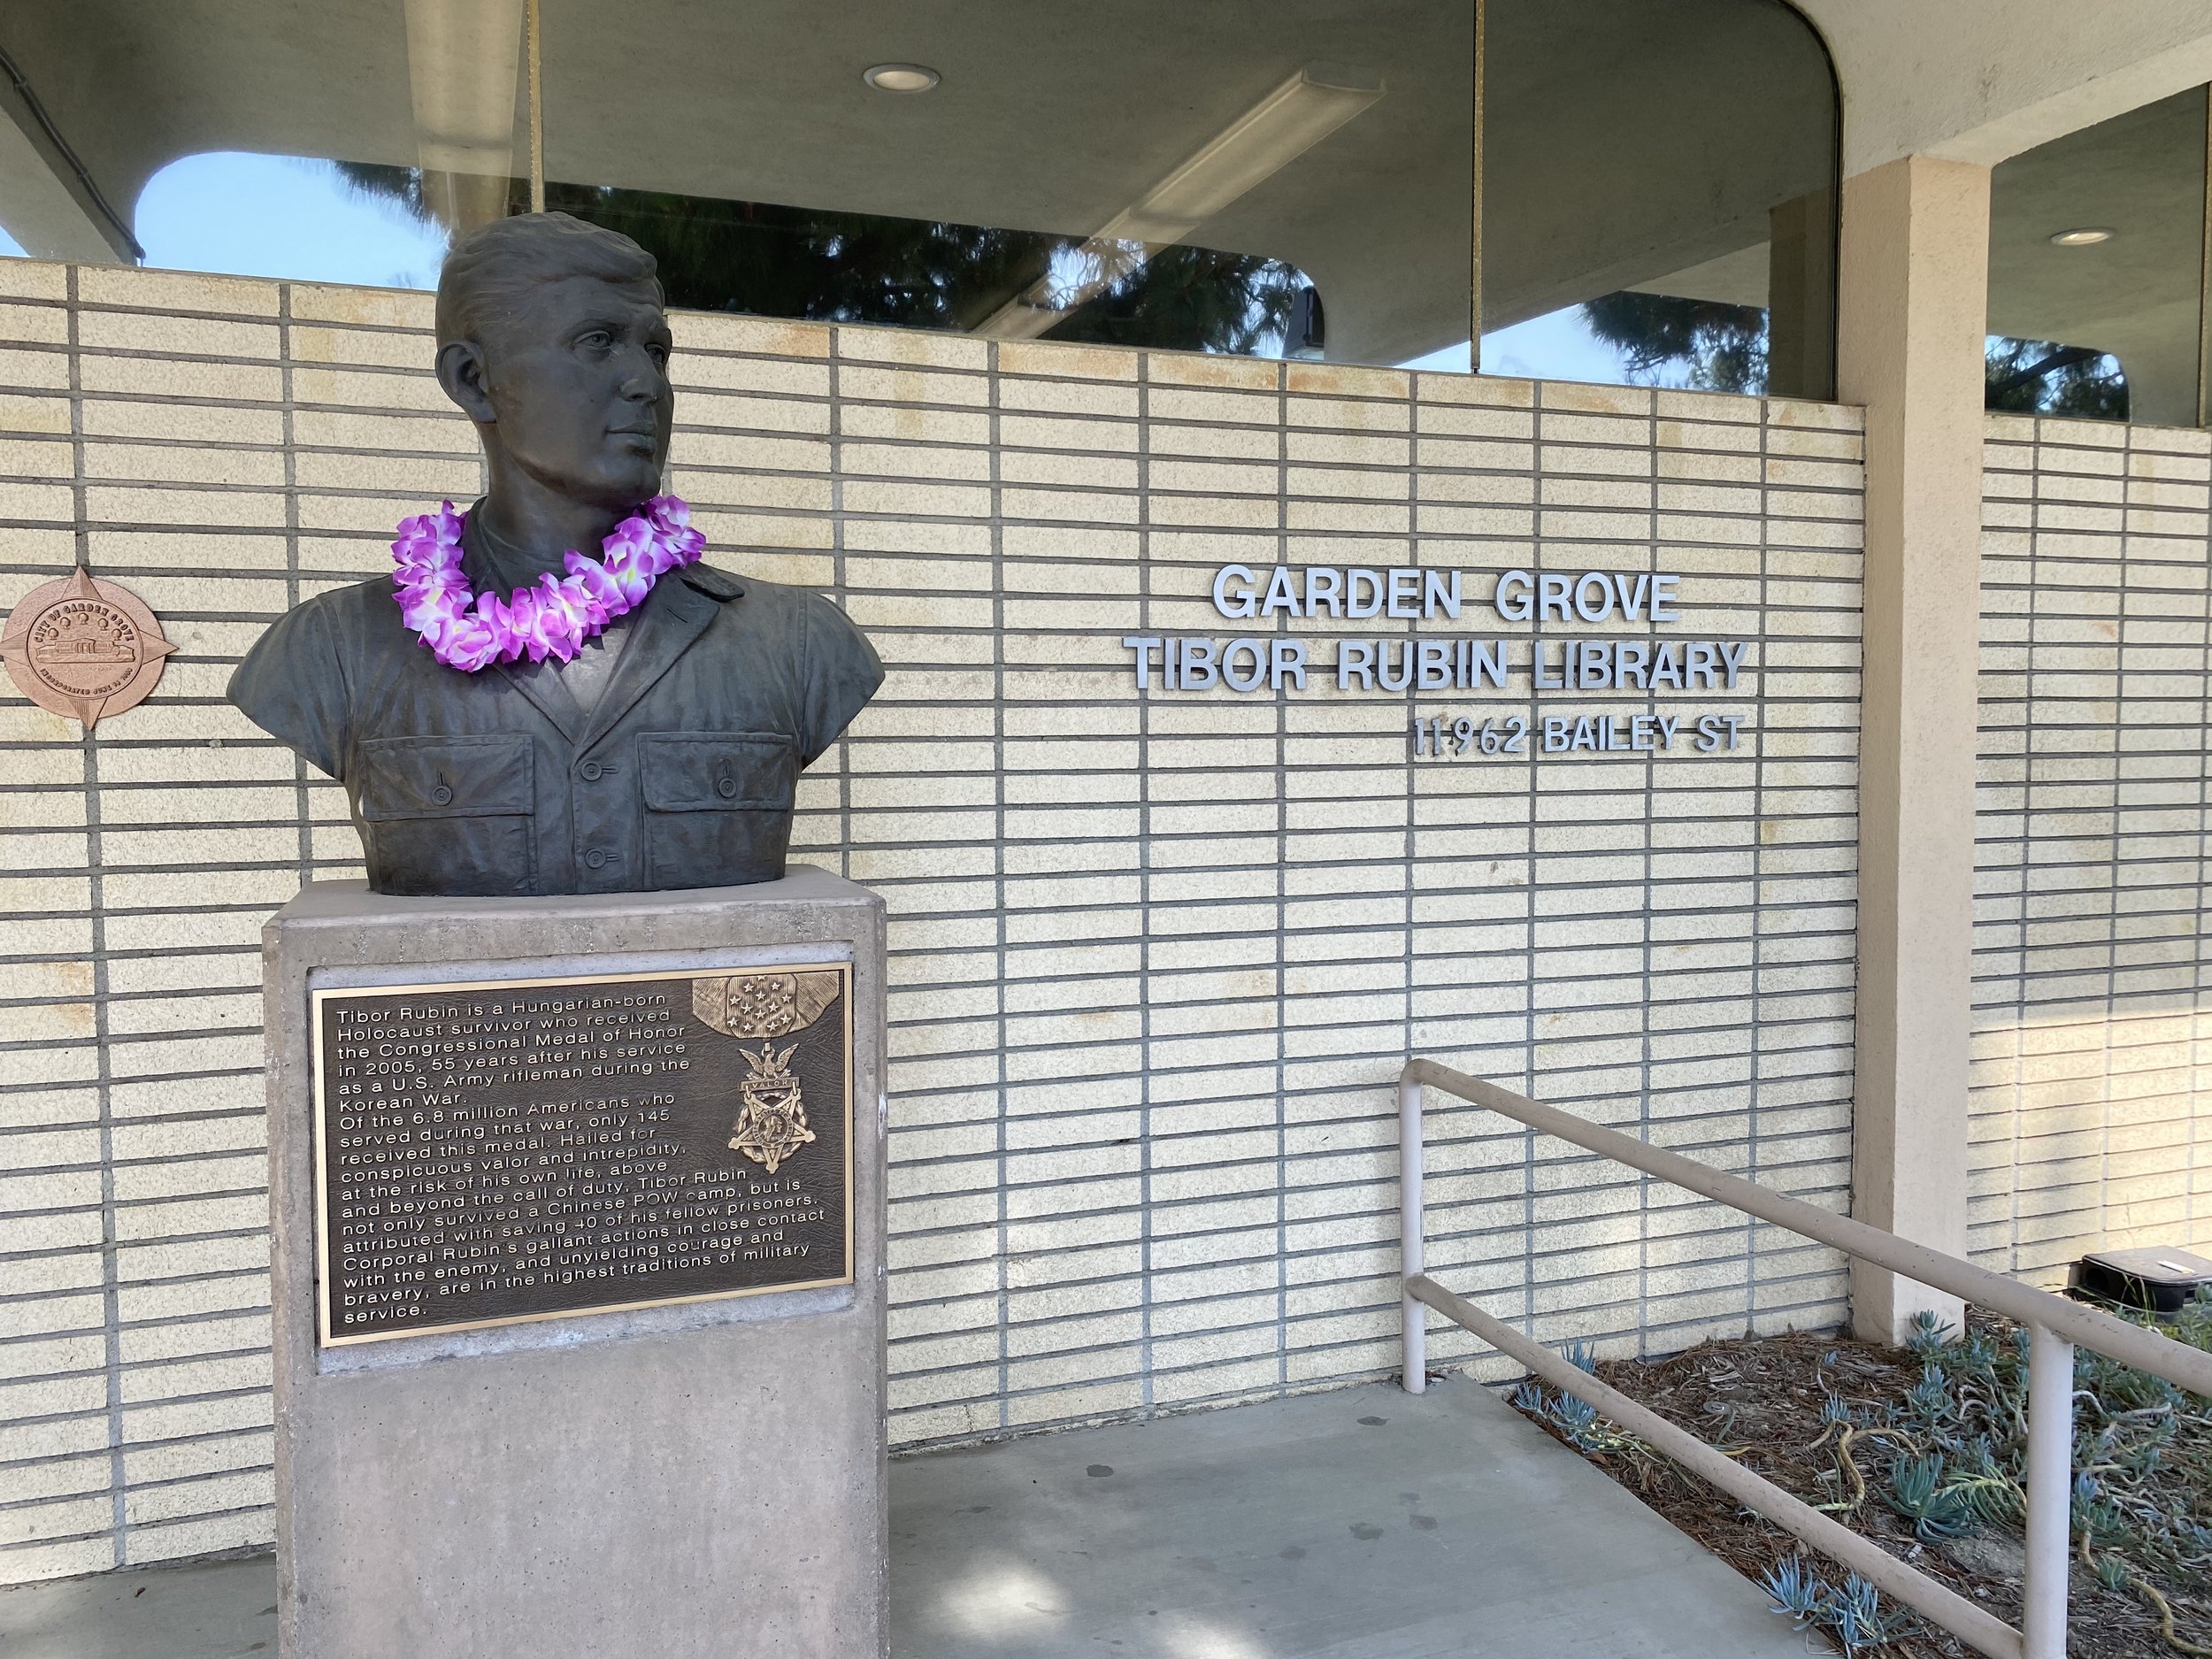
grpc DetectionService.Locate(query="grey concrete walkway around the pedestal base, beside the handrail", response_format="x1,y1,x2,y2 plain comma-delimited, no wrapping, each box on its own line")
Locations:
0,1383,1805,1659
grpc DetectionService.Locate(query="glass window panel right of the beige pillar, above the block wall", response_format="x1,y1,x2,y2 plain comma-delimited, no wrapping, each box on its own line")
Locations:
1985,87,2206,427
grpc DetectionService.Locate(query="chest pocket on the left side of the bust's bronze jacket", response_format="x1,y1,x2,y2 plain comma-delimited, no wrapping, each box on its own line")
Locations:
354,737,538,896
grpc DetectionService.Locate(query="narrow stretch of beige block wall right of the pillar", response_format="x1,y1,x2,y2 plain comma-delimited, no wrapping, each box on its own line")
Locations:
1971,416,2212,1286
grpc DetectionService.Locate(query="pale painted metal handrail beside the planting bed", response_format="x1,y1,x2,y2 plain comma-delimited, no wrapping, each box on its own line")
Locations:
1398,1060,2212,1659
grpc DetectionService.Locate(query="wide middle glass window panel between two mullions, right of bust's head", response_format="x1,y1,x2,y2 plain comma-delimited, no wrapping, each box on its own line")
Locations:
531,0,1473,363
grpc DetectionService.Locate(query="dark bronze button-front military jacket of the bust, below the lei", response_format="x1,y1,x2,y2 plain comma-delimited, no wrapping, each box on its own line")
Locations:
230,565,883,896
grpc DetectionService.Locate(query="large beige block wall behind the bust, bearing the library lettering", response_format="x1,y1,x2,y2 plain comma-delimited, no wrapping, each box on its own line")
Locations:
0,261,1863,1579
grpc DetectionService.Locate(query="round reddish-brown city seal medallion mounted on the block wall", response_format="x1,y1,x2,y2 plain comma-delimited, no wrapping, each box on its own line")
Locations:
0,566,175,733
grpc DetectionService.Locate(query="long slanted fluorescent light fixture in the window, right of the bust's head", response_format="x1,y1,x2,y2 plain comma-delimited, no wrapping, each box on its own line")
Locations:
976,65,1383,339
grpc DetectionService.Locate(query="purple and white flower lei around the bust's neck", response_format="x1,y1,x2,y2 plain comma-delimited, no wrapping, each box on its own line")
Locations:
392,495,706,675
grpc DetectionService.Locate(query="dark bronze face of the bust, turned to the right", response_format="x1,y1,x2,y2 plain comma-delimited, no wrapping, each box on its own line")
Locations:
482,277,675,509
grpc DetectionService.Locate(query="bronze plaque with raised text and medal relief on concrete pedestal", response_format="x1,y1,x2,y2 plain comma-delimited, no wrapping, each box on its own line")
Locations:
312,963,852,1345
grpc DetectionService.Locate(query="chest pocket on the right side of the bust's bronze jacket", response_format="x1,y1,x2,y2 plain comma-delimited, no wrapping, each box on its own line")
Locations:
637,733,799,887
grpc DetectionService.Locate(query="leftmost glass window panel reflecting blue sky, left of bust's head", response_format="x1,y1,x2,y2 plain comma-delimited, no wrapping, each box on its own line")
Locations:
0,0,525,286
